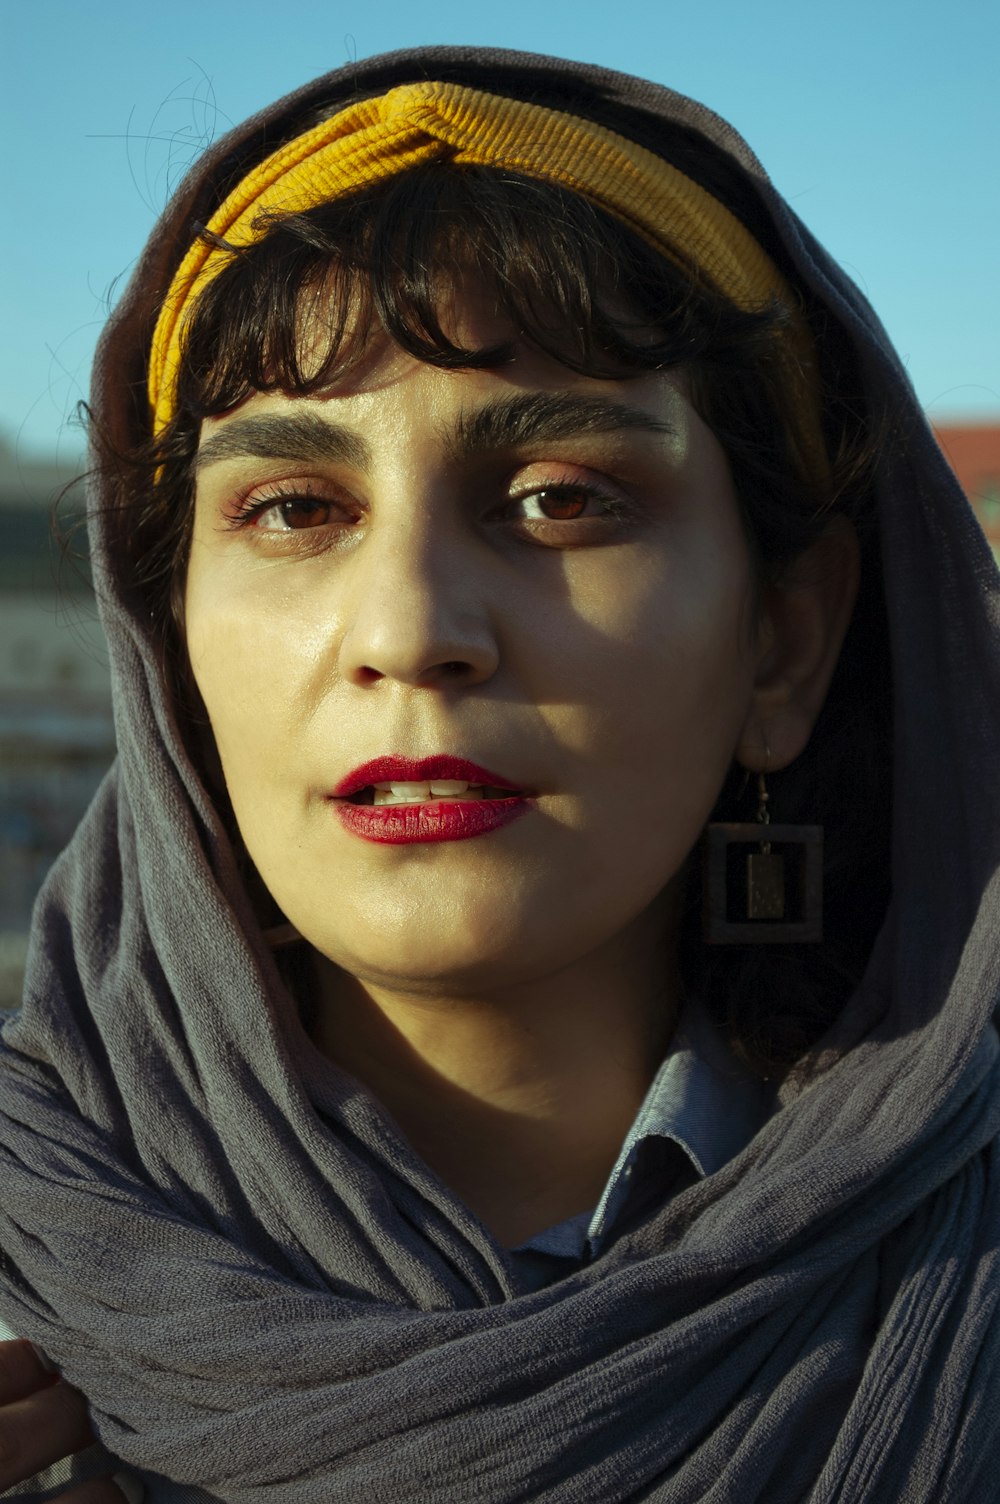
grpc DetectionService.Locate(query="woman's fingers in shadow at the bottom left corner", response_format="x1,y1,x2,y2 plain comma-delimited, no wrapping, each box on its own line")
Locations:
0,1342,125,1504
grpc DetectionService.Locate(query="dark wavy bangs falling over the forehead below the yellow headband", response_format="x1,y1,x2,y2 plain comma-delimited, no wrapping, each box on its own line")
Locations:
177,162,783,421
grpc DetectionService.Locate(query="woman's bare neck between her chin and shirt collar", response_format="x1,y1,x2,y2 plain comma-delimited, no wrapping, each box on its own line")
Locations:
306,916,677,1245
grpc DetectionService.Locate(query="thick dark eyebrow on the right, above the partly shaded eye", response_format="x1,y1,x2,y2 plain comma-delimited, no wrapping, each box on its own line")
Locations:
451,393,677,459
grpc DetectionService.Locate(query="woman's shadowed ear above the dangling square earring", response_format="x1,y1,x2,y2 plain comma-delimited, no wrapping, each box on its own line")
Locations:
735,516,860,773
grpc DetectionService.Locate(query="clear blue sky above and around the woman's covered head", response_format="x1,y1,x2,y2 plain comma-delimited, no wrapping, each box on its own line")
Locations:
0,0,1000,456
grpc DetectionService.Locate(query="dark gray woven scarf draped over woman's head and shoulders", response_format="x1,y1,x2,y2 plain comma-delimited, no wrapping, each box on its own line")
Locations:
0,50,1000,1504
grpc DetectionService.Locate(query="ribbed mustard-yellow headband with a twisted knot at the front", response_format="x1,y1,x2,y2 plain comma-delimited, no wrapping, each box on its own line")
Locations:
149,83,823,468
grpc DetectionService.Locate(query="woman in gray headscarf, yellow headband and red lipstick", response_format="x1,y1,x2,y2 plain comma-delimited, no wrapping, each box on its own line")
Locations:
0,48,1000,1504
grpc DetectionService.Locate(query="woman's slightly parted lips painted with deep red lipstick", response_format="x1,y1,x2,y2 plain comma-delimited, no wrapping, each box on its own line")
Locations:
329,754,531,845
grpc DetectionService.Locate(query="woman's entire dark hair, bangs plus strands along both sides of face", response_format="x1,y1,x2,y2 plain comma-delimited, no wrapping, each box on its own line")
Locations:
91,162,890,1074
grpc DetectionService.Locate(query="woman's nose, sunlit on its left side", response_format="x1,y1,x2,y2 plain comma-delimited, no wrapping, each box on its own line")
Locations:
340,519,499,689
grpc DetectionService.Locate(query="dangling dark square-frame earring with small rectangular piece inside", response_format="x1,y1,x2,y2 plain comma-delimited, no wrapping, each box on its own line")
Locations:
702,773,823,945
